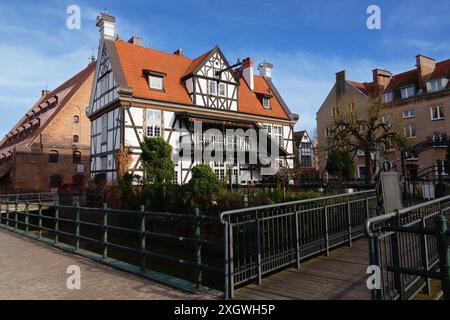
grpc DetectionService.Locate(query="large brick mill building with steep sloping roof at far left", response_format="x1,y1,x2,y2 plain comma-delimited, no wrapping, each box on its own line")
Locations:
0,62,95,193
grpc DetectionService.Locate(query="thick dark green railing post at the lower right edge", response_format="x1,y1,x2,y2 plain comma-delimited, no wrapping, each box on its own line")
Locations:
435,214,450,301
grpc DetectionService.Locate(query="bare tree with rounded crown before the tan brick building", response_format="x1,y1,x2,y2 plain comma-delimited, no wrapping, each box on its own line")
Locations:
328,99,405,184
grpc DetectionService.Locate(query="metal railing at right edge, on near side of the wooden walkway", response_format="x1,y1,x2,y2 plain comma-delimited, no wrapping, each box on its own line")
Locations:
365,196,450,300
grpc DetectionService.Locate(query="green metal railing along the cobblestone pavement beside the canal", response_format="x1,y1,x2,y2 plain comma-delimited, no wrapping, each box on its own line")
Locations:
0,195,223,291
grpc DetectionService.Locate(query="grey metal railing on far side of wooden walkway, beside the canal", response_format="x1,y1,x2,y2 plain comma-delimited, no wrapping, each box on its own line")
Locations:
221,190,377,298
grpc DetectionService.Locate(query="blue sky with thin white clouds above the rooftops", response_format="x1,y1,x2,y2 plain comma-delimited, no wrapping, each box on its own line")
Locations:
0,0,450,136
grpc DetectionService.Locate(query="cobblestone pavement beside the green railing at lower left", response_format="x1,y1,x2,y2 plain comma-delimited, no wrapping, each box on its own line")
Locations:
0,230,218,300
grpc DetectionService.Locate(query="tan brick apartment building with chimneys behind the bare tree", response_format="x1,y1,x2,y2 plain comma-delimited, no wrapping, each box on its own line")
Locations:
317,55,450,179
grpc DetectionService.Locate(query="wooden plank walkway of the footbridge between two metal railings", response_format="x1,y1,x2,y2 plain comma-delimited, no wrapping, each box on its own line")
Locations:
236,239,370,300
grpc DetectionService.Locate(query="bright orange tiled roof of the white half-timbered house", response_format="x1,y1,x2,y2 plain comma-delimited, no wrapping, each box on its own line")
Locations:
108,39,291,119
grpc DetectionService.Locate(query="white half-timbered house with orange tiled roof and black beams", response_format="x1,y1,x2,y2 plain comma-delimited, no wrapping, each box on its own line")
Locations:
88,14,298,184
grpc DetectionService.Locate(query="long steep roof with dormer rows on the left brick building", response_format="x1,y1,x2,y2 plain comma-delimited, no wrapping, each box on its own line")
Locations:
0,62,96,157
